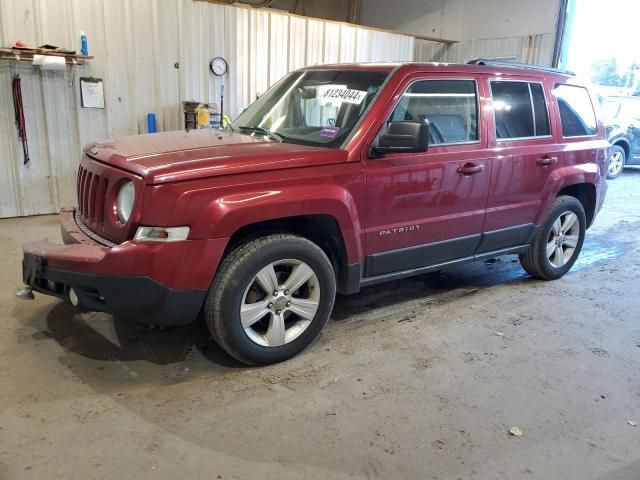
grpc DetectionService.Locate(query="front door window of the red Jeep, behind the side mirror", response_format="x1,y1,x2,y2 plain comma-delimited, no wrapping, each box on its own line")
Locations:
382,80,478,145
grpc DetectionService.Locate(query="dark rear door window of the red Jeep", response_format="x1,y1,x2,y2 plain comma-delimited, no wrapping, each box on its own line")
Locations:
491,81,551,139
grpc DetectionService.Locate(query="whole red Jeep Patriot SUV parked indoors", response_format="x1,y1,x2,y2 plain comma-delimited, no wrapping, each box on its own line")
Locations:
23,61,609,364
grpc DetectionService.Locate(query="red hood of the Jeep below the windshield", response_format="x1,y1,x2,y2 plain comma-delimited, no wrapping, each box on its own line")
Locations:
84,129,347,184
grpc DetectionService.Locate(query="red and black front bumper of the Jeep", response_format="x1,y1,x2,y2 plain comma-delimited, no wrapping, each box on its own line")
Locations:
22,210,226,325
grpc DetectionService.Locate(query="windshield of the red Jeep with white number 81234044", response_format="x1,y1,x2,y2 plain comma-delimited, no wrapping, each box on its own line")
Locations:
232,70,389,148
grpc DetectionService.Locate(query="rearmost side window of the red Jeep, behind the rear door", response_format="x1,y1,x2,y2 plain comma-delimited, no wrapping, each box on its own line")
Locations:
553,85,597,137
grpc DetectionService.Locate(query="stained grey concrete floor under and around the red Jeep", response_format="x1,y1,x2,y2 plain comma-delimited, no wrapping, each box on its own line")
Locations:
0,170,640,480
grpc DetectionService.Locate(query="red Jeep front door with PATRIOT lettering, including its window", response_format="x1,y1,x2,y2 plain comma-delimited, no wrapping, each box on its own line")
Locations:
363,75,492,277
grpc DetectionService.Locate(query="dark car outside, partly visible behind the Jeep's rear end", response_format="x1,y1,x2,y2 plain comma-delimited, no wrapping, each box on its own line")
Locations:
602,96,640,178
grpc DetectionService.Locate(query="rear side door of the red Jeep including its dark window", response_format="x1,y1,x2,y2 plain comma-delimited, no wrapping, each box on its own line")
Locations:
477,75,562,253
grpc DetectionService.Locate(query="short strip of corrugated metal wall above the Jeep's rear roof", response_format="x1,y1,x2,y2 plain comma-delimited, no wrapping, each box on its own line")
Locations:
415,33,554,65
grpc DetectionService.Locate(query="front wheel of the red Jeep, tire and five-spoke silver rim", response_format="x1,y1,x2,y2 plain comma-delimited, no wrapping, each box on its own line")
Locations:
204,234,336,365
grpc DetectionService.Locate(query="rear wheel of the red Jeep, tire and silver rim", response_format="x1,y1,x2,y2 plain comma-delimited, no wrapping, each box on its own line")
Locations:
520,195,587,280
